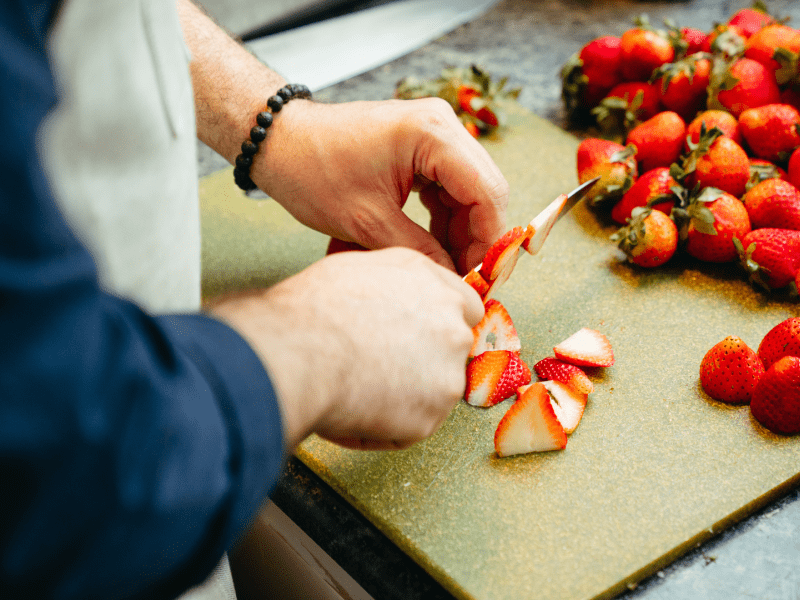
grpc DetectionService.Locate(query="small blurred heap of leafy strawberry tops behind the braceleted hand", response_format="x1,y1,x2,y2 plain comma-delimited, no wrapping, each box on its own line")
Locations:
395,65,521,138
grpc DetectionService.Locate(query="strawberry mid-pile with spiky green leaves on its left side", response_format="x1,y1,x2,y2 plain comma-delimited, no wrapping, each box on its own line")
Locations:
672,127,750,198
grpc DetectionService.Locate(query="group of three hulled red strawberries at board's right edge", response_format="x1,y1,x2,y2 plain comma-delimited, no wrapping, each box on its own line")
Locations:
700,317,800,435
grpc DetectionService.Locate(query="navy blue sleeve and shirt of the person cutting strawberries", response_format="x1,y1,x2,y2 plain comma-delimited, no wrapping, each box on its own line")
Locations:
0,0,284,600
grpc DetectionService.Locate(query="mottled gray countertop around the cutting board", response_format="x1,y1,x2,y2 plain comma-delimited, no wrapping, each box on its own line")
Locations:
201,0,800,600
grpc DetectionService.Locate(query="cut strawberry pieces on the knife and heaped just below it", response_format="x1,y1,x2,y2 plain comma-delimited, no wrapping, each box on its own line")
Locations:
464,226,614,457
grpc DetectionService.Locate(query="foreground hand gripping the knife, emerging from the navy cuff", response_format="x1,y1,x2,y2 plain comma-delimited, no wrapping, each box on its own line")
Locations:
211,248,484,449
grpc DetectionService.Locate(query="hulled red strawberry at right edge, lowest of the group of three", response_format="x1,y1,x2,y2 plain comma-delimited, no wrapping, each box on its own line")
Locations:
750,356,800,435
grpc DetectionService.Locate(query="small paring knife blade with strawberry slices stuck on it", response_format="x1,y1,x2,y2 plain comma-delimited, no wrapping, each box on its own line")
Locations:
463,177,600,303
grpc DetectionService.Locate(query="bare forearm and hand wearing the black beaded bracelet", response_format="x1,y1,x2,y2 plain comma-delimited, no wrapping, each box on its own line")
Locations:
178,0,508,273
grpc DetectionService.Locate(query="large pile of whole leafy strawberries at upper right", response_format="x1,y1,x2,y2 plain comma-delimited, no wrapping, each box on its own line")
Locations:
563,2,800,289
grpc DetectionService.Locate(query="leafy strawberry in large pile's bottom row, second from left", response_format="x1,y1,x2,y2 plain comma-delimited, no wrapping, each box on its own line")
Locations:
672,188,750,263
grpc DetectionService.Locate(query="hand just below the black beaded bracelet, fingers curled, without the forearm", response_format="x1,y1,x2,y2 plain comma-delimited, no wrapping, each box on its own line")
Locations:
251,98,508,274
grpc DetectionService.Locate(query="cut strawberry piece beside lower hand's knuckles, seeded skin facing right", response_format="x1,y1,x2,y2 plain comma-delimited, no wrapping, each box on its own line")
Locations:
464,350,531,407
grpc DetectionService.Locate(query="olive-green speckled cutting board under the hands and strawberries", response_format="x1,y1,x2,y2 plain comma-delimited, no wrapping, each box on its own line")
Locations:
201,113,800,600
